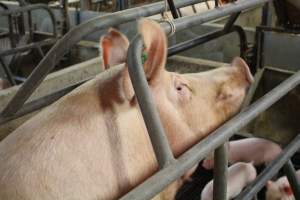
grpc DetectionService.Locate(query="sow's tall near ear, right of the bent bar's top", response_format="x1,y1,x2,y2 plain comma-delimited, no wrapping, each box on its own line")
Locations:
138,19,167,84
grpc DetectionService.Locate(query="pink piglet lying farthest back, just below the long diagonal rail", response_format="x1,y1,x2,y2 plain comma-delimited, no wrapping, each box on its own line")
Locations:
202,138,281,169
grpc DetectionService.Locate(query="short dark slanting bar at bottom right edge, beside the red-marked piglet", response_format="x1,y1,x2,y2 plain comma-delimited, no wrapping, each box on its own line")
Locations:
283,159,300,200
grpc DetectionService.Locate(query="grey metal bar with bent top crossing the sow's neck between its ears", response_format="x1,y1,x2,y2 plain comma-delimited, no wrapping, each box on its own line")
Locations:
127,36,175,168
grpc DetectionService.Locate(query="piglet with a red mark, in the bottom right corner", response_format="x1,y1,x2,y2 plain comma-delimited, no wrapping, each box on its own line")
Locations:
266,170,300,200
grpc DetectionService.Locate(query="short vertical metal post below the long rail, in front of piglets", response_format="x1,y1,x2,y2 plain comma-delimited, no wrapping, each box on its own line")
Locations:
213,143,228,200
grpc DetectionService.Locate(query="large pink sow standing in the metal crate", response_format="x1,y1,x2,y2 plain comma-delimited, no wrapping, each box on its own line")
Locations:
0,20,252,200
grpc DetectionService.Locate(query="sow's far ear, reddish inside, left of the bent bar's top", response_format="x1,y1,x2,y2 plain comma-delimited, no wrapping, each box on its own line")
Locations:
100,28,129,70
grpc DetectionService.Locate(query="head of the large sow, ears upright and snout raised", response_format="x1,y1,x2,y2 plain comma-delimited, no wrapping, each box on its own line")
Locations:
101,19,252,155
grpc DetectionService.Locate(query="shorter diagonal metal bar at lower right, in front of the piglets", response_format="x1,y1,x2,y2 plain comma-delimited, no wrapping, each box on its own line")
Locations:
235,134,300,200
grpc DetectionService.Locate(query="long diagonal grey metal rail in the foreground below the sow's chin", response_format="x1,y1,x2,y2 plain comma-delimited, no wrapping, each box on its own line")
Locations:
121,62,300,200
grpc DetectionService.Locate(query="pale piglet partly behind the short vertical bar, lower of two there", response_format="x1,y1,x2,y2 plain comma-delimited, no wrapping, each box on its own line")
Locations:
201,162,256,200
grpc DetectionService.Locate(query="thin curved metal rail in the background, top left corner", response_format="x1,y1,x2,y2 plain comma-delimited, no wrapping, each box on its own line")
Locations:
0,4,57,37
